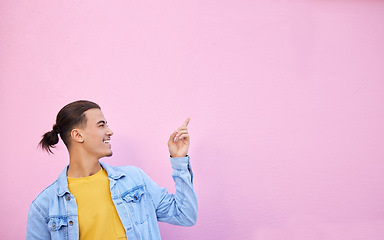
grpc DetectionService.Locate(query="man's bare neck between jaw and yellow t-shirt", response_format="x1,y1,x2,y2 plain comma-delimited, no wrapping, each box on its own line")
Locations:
67,151,101,178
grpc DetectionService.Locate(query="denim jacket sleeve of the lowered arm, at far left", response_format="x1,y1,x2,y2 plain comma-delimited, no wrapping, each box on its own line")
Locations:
25,202,51,240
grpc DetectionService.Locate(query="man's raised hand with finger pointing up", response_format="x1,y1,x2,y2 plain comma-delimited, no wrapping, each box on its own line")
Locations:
168,118,191,158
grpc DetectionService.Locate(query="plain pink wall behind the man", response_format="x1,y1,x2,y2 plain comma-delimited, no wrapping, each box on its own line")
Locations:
0,0,384,240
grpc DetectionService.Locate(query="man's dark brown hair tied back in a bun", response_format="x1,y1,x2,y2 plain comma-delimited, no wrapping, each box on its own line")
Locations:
39,100,101,153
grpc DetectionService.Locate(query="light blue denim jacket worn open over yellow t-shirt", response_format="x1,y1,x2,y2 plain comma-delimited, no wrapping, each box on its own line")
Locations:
26,156,197,240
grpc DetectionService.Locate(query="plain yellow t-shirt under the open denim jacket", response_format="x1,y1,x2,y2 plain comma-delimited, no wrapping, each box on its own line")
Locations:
67,168,127,240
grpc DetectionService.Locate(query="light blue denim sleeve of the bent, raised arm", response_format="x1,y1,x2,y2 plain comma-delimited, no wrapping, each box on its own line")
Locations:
140,156,197,226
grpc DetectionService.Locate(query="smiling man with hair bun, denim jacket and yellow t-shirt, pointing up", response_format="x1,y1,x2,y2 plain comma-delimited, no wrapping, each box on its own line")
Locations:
26,100,197,240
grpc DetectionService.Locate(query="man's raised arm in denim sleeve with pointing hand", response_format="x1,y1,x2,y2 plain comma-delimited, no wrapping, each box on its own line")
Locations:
141,118,197,226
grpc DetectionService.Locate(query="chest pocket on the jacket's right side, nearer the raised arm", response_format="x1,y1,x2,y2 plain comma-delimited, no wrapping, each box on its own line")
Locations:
122,186,150,224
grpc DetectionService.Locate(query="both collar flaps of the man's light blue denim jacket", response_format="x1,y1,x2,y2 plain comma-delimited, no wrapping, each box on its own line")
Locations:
57,162,125,197
